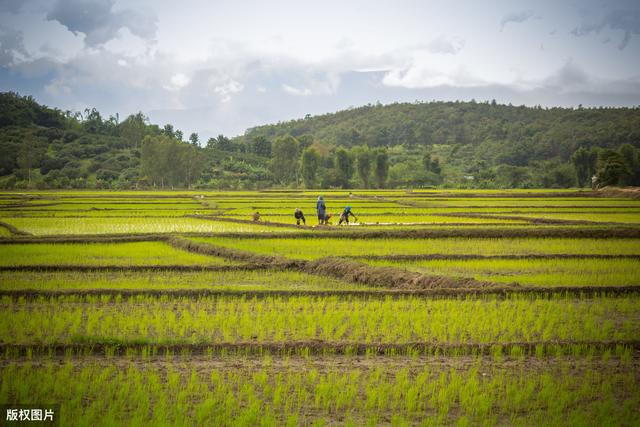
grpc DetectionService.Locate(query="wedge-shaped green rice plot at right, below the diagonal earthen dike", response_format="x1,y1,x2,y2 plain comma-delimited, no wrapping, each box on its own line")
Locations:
368,258,640,286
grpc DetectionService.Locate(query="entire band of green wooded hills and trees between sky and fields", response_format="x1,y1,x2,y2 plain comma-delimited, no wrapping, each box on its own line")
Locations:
0,93,640,189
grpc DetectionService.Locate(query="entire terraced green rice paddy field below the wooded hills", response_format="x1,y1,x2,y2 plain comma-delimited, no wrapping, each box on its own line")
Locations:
0,190,640,426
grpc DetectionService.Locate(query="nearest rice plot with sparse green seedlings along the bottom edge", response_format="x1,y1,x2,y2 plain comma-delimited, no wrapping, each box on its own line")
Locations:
0,357,640,426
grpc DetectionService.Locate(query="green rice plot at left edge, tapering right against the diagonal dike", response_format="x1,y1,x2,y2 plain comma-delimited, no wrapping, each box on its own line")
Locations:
0,242,232,266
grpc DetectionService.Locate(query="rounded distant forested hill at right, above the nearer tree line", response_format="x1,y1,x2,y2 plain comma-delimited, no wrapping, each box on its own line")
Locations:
245,101,640,154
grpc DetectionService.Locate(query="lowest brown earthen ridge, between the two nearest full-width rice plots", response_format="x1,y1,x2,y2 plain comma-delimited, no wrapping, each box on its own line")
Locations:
0,340,640,357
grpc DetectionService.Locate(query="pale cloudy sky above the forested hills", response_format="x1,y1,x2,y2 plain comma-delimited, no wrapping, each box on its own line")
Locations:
0,0,640,140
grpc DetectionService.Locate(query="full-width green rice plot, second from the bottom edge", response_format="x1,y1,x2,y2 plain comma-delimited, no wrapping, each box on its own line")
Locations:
0,295,640,345
